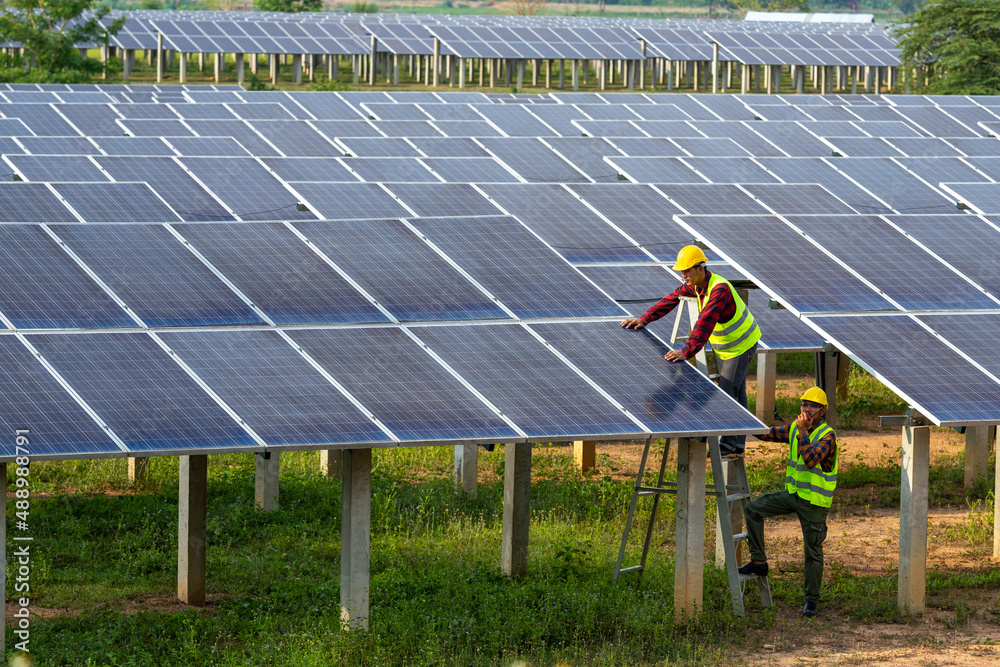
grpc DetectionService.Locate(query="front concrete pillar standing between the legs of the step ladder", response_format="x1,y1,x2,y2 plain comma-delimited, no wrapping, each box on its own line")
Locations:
674,438,706,623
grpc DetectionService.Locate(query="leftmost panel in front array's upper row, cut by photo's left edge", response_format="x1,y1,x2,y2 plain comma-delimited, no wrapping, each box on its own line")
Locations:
0,225,136,329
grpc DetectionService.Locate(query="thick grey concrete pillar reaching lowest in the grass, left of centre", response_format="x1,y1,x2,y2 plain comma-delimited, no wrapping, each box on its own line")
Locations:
340,449,372,630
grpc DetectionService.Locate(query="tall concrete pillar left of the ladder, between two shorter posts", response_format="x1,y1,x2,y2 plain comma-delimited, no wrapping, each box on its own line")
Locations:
500,442,531,577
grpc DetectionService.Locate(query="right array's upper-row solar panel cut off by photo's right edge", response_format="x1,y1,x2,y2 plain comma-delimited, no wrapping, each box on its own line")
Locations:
889,215,1000,297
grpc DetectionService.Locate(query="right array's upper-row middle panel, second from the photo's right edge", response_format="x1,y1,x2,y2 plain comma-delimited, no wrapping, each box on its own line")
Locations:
787,215,998,310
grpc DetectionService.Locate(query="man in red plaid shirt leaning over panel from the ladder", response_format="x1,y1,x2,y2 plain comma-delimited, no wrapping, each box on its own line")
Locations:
622,245,760,457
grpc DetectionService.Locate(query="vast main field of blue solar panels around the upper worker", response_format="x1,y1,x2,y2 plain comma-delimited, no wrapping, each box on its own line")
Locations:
0,85,1000,457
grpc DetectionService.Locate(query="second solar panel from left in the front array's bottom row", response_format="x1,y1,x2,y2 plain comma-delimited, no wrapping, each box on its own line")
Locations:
29,333,259,453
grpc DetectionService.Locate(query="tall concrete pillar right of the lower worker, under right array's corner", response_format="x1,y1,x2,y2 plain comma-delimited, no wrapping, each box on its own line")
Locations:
896,426,931,614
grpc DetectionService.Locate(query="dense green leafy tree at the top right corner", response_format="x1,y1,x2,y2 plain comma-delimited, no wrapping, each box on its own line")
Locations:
896,0,1000,95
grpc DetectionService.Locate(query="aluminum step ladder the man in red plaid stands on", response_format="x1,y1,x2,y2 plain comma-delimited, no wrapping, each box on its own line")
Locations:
614,297,772,616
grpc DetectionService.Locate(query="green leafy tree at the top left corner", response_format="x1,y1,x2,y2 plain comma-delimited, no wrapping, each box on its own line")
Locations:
0,0,125,83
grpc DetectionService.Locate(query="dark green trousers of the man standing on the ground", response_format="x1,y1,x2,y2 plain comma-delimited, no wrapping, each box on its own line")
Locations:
743,490,829,602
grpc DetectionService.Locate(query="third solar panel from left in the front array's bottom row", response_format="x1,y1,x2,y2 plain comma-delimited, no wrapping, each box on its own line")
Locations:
161,331,392,446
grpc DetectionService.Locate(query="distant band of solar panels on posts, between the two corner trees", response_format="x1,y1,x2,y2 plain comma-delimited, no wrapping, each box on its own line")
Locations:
101,10,899,66
